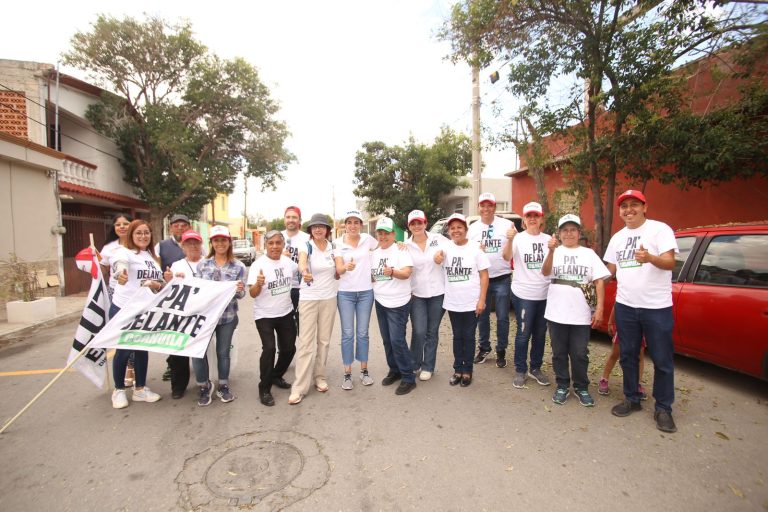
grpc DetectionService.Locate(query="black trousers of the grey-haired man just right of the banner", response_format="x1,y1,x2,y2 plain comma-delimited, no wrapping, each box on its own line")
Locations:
256,311,296,393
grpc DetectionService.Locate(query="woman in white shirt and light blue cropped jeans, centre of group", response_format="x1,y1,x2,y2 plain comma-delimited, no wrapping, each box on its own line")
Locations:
333,210,379,390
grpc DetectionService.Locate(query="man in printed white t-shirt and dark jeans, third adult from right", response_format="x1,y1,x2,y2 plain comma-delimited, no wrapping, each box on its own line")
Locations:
512,202,552,389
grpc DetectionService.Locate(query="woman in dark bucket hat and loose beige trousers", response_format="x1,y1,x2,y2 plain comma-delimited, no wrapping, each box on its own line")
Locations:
288,213,339,405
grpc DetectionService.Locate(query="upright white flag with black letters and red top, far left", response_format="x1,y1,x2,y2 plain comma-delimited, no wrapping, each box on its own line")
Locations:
67,247,110,388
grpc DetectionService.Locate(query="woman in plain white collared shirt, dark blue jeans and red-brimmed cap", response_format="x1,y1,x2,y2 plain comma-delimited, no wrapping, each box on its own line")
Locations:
405,210,450,380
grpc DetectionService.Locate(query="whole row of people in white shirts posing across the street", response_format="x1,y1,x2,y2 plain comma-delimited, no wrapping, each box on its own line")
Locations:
102,190,677,432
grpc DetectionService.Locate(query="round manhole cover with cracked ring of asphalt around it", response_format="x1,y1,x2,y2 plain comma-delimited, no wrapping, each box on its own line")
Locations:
176,431,330,510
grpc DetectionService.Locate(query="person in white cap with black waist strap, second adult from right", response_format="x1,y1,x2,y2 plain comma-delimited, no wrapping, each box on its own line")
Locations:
541,214,610,407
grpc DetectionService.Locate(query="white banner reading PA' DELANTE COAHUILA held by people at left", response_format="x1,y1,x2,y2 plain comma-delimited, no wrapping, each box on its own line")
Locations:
90,277,237,358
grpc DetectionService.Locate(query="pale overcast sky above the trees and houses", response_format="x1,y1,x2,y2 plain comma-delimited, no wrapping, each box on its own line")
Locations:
0,0,515,220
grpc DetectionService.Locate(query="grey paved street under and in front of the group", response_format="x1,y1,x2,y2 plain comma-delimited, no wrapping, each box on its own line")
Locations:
0,299,768,511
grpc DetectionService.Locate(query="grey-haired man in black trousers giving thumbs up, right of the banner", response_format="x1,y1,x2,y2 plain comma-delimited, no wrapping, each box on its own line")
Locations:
248,230,298,406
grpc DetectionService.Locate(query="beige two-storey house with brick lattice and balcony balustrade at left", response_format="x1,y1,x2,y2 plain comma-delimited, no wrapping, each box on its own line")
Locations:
0,59,149,294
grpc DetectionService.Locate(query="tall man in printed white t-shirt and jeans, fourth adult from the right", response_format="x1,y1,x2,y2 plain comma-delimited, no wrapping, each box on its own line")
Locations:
467,192,517,368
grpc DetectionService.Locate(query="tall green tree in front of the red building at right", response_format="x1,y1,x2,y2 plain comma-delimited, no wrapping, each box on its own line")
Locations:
441,0,765,249
